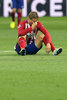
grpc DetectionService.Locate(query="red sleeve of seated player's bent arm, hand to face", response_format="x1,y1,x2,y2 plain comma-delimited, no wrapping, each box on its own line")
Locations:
17,20,32,36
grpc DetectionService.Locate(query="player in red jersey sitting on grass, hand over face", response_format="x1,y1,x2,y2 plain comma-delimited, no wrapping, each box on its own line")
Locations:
15,12,62,55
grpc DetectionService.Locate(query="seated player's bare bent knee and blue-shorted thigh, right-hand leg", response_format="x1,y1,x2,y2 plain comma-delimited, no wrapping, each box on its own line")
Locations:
26,34,44,55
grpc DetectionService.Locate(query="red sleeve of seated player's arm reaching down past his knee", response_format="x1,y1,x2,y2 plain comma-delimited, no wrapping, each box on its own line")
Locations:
37,22,51,43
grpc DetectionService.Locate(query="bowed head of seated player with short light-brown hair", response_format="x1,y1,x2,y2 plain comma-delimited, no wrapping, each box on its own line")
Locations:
28,12,39,25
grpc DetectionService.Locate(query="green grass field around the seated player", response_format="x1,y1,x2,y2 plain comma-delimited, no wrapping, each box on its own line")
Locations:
0,17,67,100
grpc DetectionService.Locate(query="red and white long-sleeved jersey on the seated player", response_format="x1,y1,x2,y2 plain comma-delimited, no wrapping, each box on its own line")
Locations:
17,20,51,44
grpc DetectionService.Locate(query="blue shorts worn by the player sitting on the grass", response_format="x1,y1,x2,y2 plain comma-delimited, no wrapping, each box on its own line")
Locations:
15,41,42,55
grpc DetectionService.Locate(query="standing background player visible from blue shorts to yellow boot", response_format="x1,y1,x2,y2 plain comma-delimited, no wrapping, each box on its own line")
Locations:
10,0,24,28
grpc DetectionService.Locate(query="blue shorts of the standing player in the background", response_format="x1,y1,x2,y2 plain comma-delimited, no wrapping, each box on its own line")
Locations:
12,0,24,9
